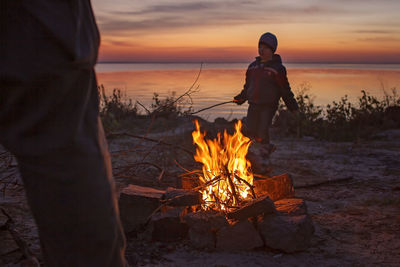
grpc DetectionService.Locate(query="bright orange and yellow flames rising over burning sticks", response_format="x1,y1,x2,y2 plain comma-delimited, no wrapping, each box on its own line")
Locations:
192,121,253,211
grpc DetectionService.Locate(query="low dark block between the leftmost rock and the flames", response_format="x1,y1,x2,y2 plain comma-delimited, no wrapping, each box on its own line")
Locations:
161,187,201,207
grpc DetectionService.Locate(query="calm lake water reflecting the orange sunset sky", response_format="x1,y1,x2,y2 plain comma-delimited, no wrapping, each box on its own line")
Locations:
97,63,400,120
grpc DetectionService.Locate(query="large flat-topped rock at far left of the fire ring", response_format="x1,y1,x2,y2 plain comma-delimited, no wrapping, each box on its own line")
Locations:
118,185,165,233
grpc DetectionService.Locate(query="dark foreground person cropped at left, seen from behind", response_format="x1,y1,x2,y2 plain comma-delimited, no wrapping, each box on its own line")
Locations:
0,0,125,266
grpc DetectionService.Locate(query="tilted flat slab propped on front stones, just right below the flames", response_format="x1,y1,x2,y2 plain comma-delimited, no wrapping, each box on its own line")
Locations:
227,196,275,221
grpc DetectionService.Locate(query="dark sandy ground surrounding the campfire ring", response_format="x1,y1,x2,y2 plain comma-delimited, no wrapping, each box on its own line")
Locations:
0,126,400,266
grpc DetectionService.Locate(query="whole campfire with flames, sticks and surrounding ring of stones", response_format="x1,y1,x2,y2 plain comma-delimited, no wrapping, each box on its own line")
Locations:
119,121,314,253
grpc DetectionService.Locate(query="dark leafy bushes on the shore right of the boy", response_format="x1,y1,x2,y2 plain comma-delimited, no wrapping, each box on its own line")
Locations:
274,84,400,141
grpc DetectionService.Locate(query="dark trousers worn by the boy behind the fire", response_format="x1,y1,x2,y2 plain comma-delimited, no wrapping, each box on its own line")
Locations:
247,104,277,144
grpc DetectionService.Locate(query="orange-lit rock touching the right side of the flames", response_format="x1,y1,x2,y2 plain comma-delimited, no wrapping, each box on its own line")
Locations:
253,174,294,201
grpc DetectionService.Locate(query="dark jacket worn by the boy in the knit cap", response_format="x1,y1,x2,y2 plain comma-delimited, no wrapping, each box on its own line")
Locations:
235,54,299,111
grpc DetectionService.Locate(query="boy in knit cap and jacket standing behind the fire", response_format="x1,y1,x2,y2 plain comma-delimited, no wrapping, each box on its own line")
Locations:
234,32,299,155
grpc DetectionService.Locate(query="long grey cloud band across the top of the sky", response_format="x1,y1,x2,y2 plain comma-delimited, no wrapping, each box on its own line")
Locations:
98,0,347,35
